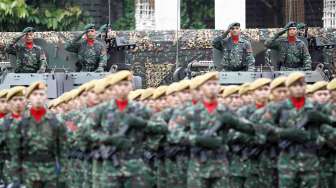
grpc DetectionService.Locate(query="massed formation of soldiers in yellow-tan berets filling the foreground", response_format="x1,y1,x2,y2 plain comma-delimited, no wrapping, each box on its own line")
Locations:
0,71,336,188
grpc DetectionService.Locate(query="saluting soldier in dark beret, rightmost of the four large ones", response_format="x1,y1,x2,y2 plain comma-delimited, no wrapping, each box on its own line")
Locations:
265,22,312,71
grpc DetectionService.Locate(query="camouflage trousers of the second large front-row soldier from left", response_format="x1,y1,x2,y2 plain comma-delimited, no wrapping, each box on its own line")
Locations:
100,159,155,188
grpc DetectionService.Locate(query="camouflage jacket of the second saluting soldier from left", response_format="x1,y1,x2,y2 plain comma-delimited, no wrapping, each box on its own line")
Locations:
65,40,107,72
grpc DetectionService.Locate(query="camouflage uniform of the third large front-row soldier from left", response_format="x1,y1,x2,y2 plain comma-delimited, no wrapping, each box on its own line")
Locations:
169,103,229,188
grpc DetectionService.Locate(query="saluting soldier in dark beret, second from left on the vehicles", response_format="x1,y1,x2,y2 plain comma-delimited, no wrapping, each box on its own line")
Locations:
65,24,107,72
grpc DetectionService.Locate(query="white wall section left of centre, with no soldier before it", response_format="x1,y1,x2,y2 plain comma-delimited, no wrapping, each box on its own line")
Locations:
155,0,181,30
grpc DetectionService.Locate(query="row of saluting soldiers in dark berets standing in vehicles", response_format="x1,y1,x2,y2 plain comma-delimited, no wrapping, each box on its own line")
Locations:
0,22,312,73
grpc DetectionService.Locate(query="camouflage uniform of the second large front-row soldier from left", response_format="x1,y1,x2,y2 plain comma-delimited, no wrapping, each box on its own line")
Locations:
82,100,153,188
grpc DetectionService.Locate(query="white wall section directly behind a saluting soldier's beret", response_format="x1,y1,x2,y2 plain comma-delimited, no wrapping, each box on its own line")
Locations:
215,0,246,29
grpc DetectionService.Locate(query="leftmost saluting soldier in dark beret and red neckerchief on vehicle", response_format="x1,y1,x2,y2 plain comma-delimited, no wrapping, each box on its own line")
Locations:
6,27,47,73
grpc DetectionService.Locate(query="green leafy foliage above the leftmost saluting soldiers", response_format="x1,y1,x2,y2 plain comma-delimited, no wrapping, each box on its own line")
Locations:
0,0,87,31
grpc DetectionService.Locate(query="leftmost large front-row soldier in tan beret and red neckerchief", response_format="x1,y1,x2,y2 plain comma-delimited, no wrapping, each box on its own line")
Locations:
8,82,65,188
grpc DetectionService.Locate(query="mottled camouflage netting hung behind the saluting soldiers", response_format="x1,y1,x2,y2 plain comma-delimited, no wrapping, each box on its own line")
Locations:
0,28,336,87
